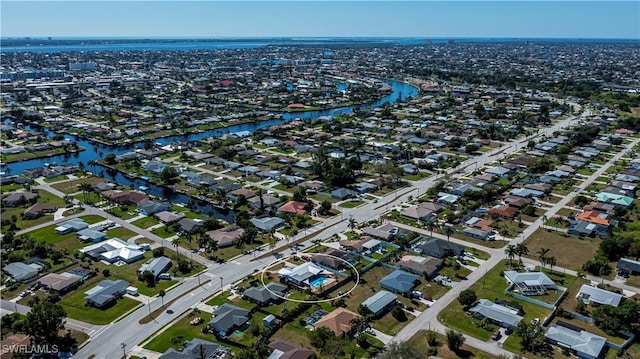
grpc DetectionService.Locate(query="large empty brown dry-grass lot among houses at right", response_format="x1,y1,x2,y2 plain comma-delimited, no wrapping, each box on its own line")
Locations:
524,228,600,270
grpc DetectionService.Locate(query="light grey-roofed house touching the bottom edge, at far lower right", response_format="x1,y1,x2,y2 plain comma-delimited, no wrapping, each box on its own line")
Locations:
544,324,607,359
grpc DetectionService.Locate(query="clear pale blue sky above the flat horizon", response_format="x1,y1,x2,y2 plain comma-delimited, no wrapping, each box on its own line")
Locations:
0,0,640,39
